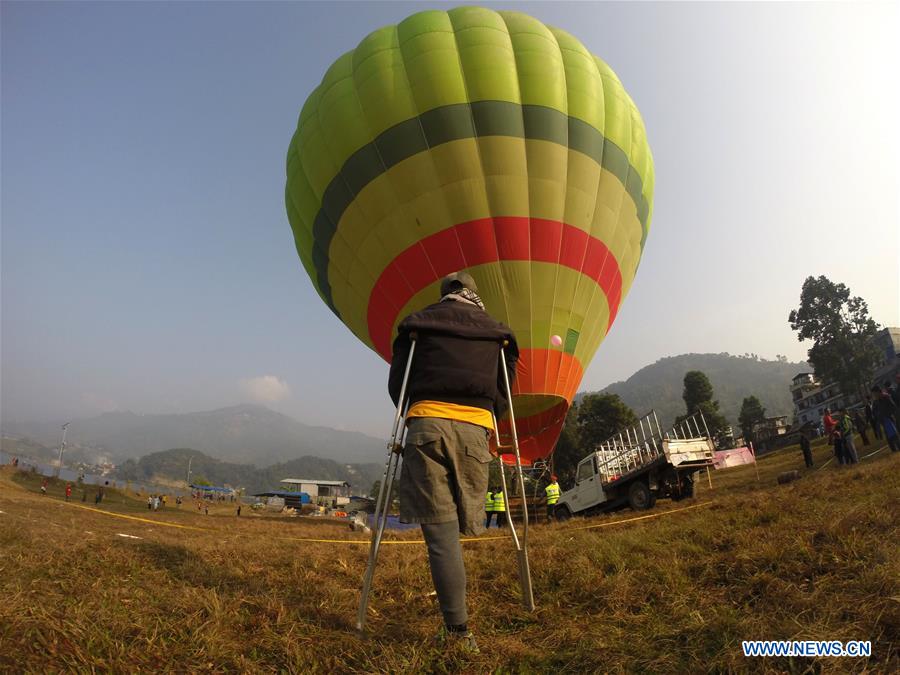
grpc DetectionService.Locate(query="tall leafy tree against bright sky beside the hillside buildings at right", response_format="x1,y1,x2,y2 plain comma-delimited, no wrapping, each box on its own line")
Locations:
788,276,880,393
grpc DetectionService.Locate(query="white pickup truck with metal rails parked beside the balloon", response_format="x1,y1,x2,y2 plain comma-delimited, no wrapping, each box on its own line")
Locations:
555,411,715,520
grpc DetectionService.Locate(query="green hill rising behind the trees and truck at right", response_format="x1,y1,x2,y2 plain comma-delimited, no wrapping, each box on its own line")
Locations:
603,353,811,426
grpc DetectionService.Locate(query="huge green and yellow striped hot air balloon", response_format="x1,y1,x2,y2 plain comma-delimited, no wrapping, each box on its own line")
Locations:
285,7,653,462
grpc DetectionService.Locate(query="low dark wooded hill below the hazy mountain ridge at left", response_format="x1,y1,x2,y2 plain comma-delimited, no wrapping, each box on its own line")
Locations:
115,448,384,494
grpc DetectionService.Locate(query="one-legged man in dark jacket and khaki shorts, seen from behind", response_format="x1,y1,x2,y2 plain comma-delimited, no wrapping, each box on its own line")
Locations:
388,272,519,653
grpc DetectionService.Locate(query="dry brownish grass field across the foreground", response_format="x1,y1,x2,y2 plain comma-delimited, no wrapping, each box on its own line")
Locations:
0,436,900,673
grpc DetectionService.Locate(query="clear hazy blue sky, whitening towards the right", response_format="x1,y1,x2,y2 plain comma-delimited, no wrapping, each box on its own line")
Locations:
0,2,900,436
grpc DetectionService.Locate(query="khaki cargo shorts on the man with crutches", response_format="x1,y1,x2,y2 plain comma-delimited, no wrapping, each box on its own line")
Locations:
397,417,493,536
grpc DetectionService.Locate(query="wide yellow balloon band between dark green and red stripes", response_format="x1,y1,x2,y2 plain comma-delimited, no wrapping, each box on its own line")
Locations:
329,137,642,347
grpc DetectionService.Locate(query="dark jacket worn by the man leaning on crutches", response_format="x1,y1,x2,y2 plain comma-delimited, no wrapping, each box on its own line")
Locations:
388,300,519,418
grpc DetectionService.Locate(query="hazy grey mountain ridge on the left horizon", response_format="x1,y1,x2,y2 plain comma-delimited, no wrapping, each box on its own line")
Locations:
3,405,385,466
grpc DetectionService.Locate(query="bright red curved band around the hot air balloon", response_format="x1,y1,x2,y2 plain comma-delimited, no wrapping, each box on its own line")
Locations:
367,216,622,361
